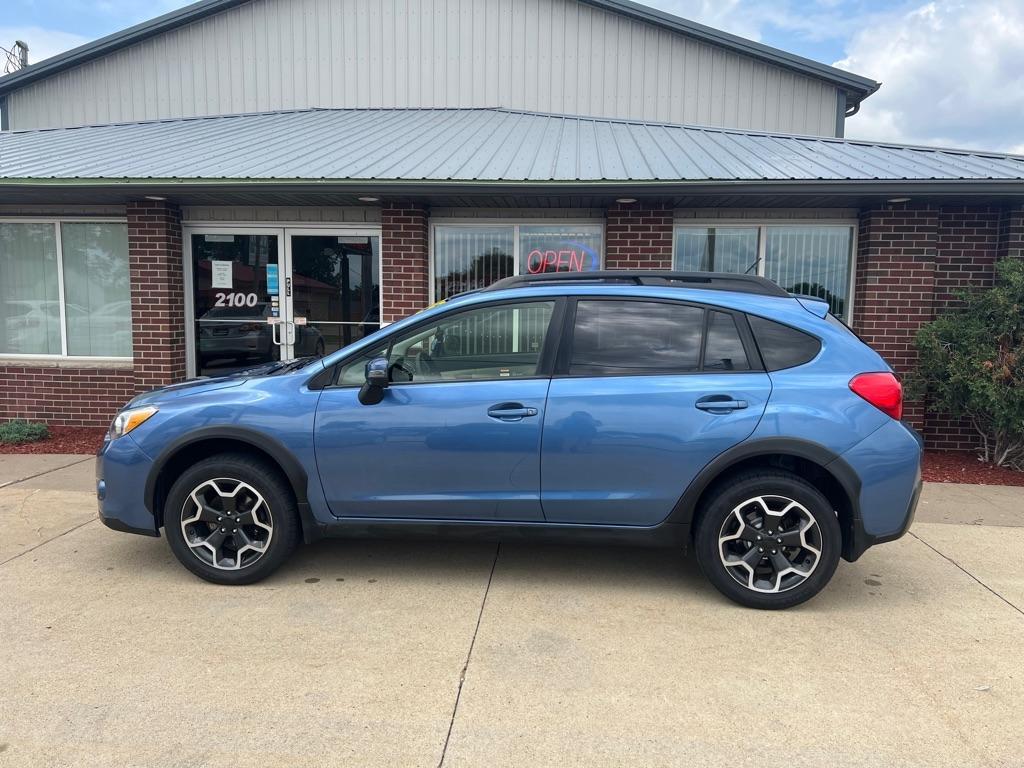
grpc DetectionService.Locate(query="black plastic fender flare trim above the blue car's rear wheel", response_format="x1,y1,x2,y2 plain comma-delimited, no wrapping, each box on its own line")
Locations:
666,437,860,525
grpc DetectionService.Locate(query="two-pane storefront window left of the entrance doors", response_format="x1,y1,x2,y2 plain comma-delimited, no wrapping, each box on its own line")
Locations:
0,221,131,357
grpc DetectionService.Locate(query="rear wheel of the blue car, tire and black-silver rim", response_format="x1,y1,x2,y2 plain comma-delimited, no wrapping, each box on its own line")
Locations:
695,470,843,609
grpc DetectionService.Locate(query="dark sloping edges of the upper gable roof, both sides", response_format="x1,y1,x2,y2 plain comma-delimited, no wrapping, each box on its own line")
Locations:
0,0,880,103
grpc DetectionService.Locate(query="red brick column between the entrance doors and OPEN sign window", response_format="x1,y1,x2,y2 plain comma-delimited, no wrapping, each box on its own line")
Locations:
381,203,429,323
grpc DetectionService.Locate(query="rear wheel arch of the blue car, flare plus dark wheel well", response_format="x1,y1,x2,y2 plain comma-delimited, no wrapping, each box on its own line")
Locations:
669,437,860,560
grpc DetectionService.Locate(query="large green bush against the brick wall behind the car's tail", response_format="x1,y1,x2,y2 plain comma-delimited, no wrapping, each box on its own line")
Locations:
914,259,1024,469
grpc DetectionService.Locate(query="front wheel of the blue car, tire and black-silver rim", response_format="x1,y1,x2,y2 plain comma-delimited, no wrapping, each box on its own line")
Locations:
164,454,299,585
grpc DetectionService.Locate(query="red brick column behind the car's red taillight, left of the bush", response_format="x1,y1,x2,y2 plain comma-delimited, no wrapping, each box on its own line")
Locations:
853,207,938,429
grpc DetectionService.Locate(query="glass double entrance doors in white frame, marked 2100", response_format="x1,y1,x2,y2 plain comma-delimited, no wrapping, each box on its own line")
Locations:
184,225,381,376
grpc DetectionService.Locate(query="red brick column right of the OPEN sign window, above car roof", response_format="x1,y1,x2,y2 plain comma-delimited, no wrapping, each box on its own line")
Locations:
604,203,672,269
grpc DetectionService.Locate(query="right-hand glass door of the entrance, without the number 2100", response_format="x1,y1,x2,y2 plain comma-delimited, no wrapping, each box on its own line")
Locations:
285,229,381,357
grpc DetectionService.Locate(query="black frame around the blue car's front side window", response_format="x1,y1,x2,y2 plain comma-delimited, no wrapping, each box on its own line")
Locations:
323,295,568,389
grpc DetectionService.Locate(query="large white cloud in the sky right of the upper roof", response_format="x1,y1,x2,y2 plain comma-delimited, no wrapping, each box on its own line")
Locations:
837,0,1024,153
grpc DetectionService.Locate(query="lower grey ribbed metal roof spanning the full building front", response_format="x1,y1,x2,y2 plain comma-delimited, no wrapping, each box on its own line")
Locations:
0,109,1024,187
